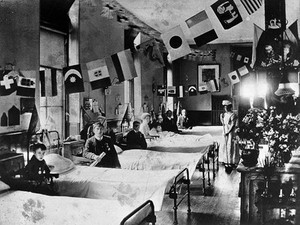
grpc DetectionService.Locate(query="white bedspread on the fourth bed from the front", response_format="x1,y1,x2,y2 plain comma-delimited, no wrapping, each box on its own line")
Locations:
147,134,214,153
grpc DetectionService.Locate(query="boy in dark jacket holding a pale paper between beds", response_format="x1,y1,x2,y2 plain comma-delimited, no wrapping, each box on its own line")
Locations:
82,122,121,168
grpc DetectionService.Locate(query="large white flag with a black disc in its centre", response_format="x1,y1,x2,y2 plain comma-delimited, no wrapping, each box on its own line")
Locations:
161,25,191,61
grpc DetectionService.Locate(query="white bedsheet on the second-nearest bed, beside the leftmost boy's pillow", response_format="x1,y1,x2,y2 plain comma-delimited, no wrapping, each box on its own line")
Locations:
55,166,179,210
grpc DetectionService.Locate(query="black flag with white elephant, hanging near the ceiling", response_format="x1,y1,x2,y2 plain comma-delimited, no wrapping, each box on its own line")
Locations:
211,0,243,30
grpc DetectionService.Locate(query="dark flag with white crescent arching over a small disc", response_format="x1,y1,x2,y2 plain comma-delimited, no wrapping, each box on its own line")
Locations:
63,65,84,94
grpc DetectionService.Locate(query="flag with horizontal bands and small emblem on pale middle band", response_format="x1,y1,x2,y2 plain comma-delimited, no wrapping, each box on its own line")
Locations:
86,58,111,90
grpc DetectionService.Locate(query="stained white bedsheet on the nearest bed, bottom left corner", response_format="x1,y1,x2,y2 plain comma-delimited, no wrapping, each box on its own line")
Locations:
0,191,151,225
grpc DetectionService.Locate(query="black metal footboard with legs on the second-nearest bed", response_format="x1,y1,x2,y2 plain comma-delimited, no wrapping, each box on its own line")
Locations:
169,168,191,224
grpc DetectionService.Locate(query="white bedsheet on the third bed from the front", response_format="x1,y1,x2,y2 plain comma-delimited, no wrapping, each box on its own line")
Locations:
118,149,209,179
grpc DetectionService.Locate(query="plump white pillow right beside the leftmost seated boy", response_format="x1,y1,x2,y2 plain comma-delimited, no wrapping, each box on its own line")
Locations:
44,153,75,174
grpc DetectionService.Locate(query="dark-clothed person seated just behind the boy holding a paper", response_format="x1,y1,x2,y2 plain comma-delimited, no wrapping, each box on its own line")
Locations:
127,121,147,149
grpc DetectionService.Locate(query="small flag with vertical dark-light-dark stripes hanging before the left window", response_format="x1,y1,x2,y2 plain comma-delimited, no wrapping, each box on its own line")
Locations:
40,68,57,97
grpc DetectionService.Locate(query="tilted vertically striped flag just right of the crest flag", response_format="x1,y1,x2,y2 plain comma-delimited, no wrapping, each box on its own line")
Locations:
106,49,137,82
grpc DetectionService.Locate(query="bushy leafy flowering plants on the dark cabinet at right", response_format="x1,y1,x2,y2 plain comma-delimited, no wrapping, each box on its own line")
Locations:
237,106,300,166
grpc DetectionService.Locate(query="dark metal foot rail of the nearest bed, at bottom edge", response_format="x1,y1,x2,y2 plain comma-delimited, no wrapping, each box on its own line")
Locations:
120,200,156,225
